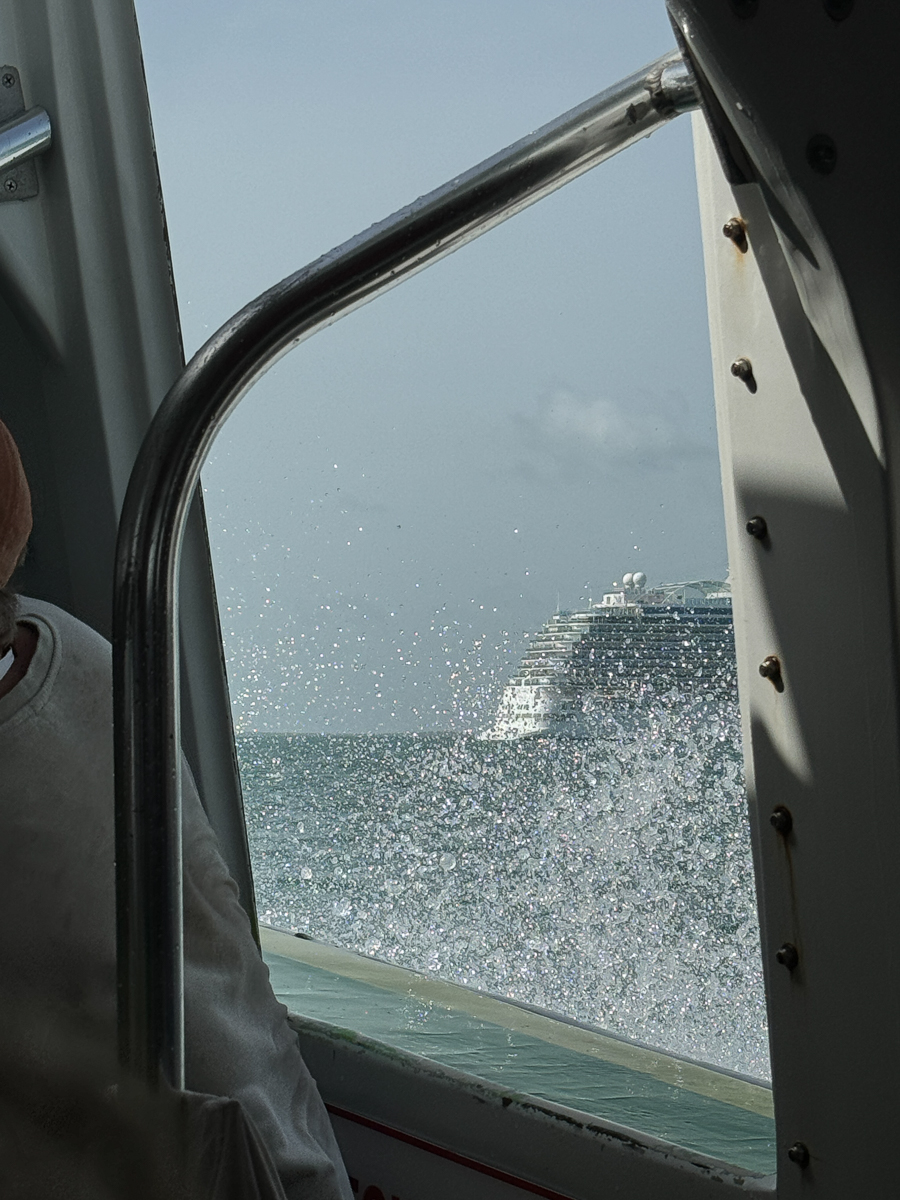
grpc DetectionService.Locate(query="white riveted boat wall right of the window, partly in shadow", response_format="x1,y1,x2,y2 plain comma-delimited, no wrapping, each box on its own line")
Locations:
670,0,900,1200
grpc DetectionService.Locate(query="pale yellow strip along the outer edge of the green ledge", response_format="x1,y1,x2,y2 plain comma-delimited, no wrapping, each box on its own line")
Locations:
259,926,774,1117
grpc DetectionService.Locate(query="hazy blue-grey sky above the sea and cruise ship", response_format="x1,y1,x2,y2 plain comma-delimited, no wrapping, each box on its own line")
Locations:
137,0,726,732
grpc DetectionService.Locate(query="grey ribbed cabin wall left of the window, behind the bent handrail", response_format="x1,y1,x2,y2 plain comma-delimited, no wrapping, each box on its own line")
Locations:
0,0,256,920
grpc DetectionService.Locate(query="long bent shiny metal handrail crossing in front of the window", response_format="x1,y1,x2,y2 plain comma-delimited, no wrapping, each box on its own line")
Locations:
113,53,697,1087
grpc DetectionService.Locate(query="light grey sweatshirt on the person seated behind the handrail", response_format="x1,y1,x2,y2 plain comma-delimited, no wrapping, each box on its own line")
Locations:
0,598,350,1200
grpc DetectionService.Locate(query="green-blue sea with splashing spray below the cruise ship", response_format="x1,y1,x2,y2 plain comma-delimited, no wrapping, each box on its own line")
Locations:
239,697,769,1078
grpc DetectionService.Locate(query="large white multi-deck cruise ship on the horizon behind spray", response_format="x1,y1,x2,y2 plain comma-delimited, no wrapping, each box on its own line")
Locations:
484,571,736,740
